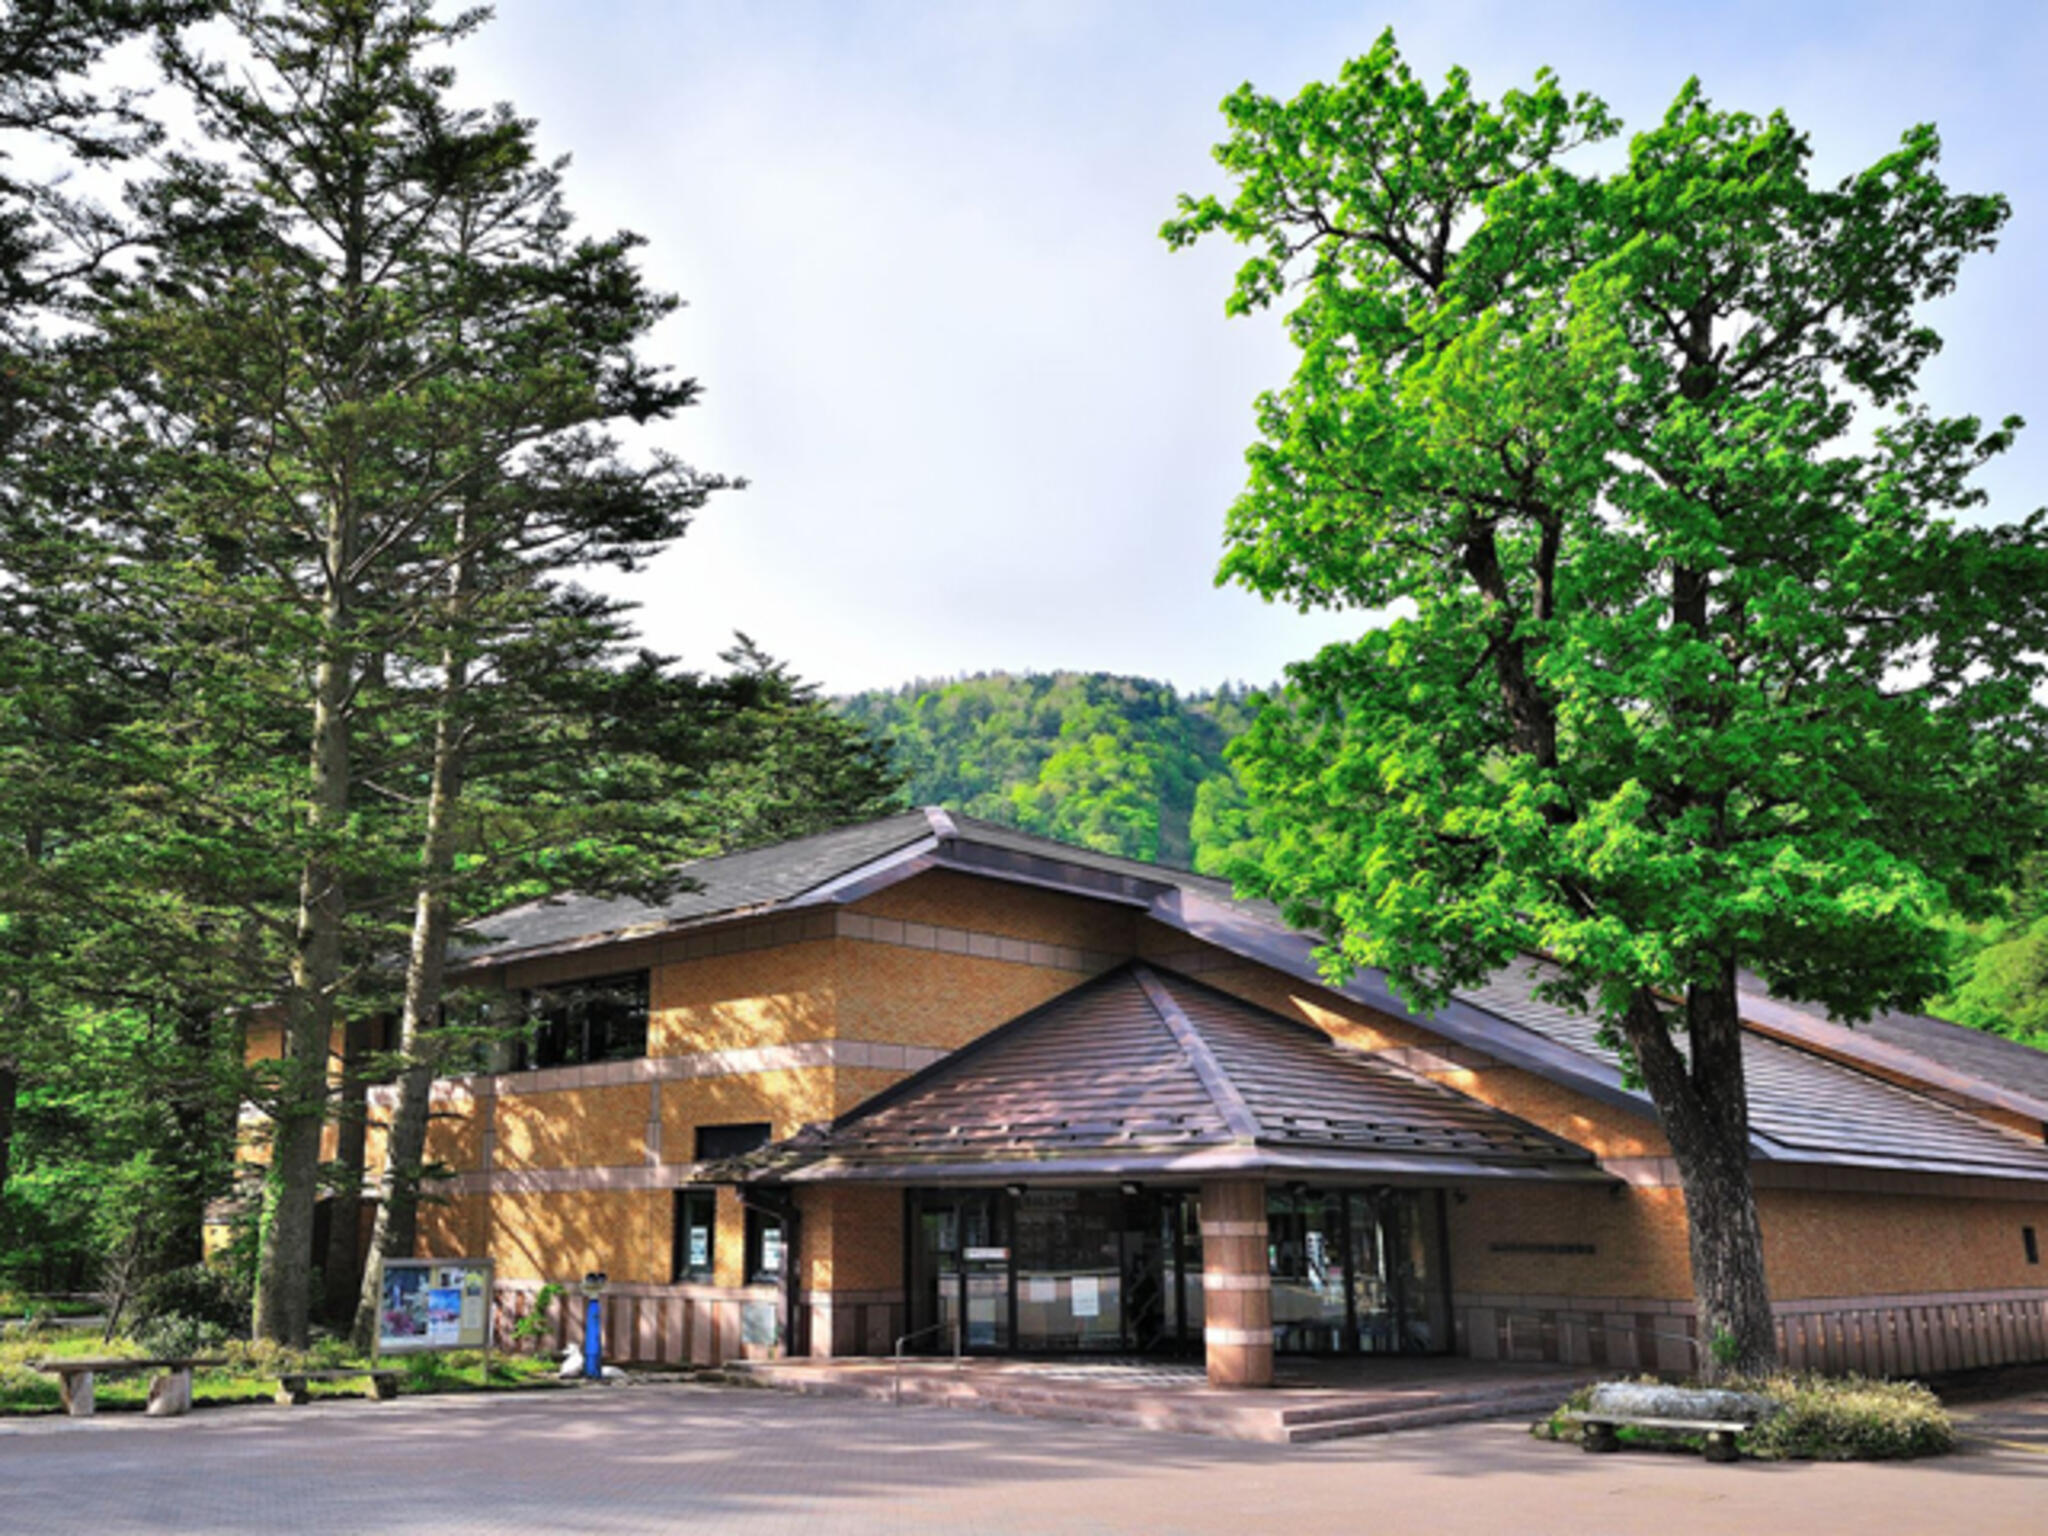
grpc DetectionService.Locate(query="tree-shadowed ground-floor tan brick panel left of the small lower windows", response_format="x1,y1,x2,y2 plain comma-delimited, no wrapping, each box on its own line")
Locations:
489,1190,663,1284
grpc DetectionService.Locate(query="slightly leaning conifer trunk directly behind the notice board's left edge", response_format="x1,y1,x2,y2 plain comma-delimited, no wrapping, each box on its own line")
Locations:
354,536,477,1350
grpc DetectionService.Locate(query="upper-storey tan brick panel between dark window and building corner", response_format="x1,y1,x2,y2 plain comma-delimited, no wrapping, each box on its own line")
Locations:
647,940,838,1057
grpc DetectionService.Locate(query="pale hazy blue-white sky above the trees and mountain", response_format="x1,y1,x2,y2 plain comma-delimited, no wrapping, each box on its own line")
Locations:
436,0,2048,690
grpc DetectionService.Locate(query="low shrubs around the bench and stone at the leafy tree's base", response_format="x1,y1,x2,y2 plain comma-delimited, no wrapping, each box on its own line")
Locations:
1530,1374,1956,1462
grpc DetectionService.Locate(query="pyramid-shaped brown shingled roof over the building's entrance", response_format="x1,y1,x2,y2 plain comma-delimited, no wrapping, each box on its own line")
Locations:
702,963,1608,1184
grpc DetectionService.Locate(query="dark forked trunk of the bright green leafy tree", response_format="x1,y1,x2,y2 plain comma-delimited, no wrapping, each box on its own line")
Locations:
1622,961,1778,1380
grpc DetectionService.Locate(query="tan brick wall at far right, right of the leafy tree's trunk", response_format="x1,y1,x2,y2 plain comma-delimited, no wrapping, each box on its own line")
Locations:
1757,1190,2048,1300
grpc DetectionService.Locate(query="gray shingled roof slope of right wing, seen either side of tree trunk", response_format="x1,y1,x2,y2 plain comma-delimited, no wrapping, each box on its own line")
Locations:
1464,961,2048,1180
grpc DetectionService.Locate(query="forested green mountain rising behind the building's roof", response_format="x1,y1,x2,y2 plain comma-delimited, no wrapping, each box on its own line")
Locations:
840,672,1251,874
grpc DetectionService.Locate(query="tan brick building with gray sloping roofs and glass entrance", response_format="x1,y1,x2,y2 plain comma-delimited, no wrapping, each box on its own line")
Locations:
296,811,2048,1384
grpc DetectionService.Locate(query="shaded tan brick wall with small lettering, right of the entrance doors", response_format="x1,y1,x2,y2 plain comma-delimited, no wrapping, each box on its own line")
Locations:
1446,1182,1692,1300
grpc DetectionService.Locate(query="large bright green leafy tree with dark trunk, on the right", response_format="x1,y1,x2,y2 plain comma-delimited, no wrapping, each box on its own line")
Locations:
1163,35,2048,1372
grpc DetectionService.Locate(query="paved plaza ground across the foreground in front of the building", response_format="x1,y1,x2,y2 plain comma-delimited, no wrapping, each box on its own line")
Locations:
0,1386,2048,1536
